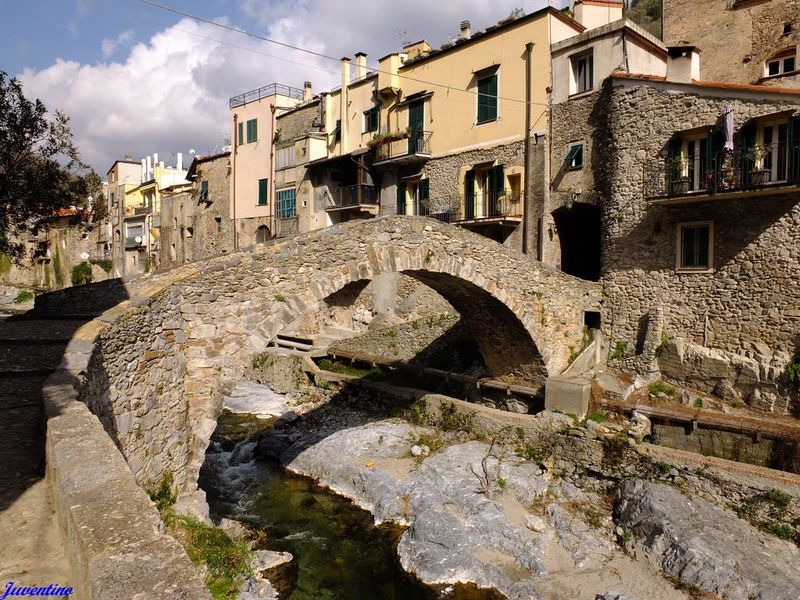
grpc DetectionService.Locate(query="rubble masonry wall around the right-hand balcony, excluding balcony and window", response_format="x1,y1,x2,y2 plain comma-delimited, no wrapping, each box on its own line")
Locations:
602,82,800,384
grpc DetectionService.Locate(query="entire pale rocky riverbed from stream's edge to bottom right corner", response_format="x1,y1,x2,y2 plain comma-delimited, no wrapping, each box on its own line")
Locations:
203,384,800,600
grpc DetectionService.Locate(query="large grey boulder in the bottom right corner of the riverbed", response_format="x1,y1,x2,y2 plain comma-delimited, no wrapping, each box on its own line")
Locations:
617,480,800,600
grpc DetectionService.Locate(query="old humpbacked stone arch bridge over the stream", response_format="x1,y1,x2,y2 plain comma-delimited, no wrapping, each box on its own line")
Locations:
76,216,601,502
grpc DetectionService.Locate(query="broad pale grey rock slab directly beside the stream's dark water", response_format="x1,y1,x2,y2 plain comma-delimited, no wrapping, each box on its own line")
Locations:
283,421,685,600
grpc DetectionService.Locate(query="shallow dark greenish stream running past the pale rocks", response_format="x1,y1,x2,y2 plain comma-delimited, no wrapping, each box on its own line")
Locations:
200,410,502,600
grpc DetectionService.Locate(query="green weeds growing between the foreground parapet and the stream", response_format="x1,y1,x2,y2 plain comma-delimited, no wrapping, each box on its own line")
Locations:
144,471,253,600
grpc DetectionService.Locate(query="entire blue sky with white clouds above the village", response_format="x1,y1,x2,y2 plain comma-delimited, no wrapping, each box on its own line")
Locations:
0,0,566,175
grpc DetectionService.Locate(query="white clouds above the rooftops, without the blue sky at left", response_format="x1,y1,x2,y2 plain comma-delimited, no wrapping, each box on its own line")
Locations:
19,0,566,175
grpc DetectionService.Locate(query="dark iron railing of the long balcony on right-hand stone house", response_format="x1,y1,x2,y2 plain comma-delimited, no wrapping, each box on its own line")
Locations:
644,142,800,200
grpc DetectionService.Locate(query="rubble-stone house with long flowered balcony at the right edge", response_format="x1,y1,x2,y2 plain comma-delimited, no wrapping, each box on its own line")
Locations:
576,73,800,411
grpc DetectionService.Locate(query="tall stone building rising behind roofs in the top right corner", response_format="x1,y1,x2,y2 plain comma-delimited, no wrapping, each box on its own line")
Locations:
663,0,800,87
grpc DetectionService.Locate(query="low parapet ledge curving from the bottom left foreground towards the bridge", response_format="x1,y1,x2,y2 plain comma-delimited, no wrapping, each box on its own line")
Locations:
43,290,211,600
